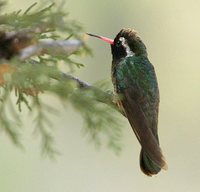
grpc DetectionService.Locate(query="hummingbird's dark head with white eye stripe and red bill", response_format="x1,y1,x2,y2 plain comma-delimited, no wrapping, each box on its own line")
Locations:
88,28,147,60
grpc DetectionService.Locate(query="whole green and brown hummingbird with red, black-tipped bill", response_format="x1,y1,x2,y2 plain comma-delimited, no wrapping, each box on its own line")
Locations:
88,28,167,176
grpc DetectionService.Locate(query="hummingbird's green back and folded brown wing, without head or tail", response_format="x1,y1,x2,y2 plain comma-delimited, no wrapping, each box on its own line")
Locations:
115,56,166,168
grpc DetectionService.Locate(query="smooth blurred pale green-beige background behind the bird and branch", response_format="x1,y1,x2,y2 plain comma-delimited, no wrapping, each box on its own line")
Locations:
0,0,200,192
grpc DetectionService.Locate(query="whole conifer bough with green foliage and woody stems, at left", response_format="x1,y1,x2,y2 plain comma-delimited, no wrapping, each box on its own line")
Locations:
0,0,124,157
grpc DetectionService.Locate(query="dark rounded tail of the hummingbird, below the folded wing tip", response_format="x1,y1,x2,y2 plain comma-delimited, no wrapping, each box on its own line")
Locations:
140,149,161,176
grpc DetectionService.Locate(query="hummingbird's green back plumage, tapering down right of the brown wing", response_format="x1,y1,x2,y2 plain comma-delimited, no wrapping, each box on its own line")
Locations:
115,56,159,132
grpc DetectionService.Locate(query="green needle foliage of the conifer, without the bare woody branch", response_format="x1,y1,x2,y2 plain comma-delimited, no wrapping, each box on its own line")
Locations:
0,2,121,157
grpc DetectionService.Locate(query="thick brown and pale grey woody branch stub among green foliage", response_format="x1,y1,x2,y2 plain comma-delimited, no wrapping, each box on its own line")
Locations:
0,30,84,61
